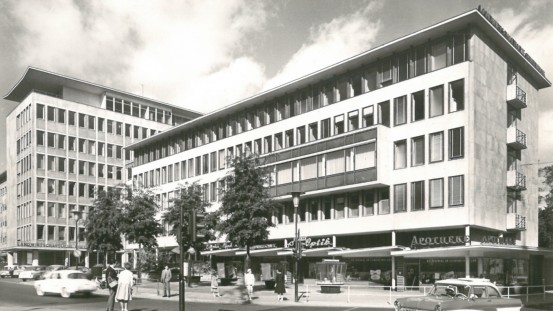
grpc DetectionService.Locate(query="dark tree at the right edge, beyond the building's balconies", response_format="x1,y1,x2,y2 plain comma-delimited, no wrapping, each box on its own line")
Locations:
538,165,553,247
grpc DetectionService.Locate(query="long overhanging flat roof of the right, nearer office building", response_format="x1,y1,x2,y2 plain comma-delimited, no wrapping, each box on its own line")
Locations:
127,8,551,149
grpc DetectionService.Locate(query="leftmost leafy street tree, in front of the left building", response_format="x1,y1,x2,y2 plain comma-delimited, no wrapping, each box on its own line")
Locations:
85,188,123,264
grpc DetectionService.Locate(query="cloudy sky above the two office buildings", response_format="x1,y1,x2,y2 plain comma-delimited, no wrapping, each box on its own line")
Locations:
0,0,553,171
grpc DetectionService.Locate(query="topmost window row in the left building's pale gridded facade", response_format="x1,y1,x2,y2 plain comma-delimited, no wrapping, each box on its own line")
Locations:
36,104,156,139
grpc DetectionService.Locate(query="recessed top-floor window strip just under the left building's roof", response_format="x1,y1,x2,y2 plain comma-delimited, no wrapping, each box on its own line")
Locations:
106,96,186,125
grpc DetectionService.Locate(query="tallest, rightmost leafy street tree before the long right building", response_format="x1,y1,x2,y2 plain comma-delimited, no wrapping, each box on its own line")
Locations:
217,155,277,269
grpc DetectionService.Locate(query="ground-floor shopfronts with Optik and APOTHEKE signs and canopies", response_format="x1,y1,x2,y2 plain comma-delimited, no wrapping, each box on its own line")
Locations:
203,228,553,286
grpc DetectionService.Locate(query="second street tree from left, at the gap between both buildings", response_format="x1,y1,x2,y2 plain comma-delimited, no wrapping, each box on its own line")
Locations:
121,188,162,277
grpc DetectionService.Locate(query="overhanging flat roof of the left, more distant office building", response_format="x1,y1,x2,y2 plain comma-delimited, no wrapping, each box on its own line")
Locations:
4,67,203,119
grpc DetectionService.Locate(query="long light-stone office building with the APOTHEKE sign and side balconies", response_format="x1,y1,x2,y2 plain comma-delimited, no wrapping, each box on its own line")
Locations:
129,8,553,284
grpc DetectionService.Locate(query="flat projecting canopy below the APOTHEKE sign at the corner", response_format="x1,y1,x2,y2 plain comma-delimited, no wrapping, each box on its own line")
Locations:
391,245,553,258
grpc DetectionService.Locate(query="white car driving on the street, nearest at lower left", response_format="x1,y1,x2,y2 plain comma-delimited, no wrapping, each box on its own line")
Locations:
34,270,96,298
